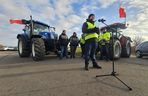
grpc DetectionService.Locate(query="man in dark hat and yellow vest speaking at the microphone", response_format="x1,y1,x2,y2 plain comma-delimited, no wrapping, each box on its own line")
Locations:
82,14,102,71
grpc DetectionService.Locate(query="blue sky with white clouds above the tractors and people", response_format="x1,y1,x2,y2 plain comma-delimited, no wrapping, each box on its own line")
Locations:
0,0,148,46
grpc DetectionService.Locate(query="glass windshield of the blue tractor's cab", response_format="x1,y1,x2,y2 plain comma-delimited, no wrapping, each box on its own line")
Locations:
33,23,49,34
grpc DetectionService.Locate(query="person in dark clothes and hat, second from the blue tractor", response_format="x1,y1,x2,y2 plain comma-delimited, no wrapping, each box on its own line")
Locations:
69,32,79,58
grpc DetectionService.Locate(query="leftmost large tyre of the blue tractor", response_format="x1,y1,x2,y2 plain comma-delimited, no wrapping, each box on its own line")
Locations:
18,37,30,57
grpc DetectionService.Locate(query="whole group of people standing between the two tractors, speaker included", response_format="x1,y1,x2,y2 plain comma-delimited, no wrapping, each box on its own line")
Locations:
59,14,110,71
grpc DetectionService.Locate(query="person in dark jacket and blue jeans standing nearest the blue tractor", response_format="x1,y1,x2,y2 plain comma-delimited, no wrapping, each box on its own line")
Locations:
59,30,69,59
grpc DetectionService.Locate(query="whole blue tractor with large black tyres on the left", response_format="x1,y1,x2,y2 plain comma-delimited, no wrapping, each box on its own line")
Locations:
13,16,58,61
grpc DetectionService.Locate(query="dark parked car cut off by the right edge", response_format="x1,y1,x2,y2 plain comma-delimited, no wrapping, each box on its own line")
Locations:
135,41,148,58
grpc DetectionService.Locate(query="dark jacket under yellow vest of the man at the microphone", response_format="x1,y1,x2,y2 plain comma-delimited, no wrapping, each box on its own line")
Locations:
82,19,99,34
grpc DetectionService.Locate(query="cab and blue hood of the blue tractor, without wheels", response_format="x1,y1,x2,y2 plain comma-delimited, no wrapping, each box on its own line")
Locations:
22,20,57,39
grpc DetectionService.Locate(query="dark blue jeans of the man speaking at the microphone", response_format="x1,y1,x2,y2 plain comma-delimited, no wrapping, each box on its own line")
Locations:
85,39,98,63
